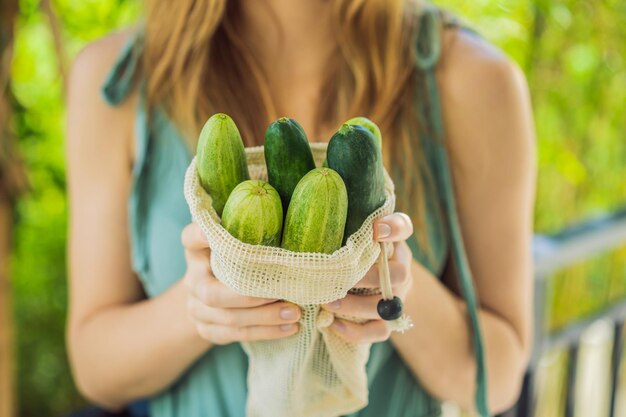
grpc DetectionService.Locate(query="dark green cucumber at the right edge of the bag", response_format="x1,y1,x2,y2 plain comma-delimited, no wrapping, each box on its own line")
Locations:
326,124,386,243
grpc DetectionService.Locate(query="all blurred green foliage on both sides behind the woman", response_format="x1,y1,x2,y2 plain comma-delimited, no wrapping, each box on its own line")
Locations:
12,0,626,417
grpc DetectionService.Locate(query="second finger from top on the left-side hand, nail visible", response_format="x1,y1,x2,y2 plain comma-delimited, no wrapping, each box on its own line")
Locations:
188,298,302,327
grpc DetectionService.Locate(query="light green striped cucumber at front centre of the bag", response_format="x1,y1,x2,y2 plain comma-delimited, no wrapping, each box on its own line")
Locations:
281,168,348,253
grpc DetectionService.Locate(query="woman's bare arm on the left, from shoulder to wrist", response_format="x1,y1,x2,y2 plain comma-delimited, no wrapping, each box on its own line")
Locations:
67,35,210,408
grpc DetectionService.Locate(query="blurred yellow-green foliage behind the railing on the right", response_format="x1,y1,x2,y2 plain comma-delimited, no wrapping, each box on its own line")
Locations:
437,0,626,328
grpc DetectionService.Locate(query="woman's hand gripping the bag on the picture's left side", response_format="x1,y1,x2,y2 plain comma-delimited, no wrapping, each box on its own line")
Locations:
182,223,301,345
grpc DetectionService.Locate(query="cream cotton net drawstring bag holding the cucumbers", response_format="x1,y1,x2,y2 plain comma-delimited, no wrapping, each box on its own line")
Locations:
185,144,409,417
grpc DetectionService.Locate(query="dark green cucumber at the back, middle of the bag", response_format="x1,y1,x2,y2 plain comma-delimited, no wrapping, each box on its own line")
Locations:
264,117,315,211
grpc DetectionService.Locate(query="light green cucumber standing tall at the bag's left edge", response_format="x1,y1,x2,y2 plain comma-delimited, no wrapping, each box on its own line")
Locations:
196,113,250,216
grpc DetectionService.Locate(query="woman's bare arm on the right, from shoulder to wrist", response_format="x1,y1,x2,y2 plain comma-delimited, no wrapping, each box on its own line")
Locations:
392,33,535,411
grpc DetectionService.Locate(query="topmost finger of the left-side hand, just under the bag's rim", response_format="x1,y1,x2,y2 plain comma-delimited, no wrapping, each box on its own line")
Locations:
190,275,276,308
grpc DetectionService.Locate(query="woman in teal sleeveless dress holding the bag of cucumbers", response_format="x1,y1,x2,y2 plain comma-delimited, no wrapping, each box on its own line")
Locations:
68,0,534,417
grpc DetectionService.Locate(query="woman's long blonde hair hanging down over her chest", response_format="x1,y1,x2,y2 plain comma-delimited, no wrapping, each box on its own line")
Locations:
142,0,432,243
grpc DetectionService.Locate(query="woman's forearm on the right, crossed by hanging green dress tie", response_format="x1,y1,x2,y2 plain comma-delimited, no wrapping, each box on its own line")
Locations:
392,267,526,411
